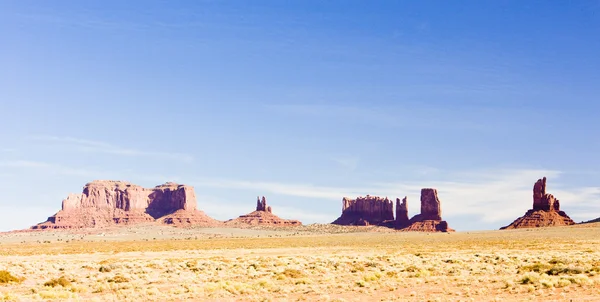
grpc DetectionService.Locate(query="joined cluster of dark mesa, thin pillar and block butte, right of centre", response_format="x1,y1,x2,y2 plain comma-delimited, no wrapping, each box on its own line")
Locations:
332,188,454,232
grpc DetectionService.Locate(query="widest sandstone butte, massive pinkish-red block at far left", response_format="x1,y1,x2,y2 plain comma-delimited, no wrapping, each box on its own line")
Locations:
31,180,221,229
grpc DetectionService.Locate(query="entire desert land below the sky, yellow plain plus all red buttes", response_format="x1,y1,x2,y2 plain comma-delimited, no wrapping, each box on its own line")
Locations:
0,178,600,301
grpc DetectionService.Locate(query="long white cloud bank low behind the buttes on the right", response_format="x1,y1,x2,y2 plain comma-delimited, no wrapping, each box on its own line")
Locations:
194,169,600,223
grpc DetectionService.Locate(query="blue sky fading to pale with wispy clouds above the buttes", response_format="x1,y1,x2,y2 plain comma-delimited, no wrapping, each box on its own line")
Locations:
0,0,600,230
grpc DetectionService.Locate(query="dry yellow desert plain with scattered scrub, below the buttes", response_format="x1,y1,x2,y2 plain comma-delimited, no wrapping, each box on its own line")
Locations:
0,223,600,301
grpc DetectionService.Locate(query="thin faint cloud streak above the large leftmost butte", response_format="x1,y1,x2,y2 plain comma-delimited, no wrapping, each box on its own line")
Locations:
30,136,194,162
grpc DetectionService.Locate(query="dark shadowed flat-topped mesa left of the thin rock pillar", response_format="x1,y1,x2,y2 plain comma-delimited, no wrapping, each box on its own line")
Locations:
333,195,394,225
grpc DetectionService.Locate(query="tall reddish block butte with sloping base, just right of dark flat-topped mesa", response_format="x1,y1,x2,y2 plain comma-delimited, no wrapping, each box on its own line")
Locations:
401,188,454,232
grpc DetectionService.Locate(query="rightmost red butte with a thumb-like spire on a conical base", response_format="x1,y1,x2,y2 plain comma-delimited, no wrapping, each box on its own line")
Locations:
500,177,575,230
